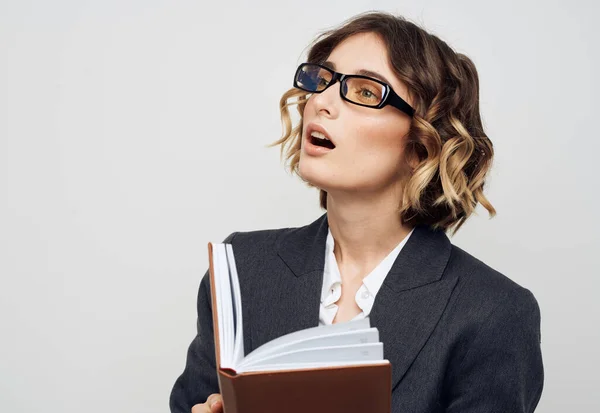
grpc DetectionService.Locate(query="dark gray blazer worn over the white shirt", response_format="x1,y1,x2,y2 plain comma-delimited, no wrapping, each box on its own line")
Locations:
170,214,544,413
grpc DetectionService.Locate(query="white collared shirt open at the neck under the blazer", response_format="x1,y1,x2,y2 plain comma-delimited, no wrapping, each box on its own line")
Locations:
319,230,413,325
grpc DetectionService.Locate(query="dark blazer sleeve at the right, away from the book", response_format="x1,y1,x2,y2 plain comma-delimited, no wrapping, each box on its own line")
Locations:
446,288,544,413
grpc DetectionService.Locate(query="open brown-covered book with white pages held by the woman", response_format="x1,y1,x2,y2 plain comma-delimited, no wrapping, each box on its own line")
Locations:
208,243,391,413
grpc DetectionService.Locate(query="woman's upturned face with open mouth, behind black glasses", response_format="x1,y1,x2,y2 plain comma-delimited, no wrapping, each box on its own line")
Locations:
299,33,411,194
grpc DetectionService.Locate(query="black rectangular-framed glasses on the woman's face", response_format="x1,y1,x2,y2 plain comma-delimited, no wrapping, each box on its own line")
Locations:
294,63,415,117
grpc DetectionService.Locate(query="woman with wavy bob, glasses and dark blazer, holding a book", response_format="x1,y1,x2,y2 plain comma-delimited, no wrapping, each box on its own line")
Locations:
171,12,543,413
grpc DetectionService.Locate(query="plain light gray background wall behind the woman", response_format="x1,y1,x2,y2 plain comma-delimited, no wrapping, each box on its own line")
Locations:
0,0,600,412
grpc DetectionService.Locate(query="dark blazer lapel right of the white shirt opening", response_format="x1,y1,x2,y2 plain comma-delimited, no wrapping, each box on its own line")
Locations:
370,227,457,389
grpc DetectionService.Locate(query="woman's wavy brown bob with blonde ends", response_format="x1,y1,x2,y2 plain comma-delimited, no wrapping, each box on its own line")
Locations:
272,12,496,233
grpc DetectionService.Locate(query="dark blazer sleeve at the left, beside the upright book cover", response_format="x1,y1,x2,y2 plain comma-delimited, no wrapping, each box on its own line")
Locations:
169,233,235,413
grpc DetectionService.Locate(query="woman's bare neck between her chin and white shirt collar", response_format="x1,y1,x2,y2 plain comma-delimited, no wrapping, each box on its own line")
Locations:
327,188,412,268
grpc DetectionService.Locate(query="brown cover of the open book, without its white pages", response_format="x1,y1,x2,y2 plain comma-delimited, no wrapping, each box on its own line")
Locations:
208,243,392,413
